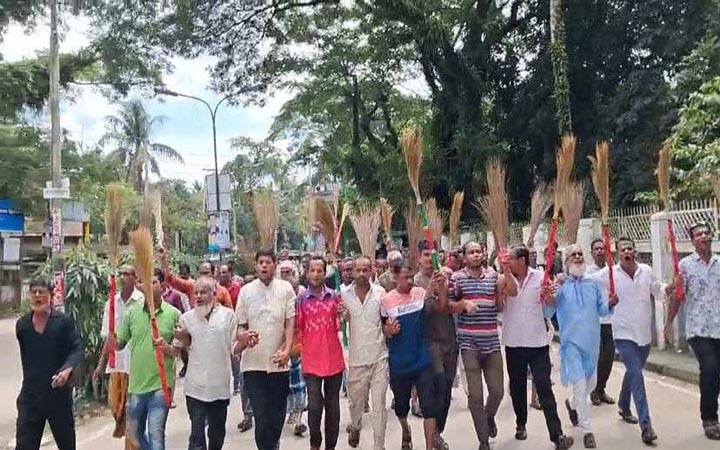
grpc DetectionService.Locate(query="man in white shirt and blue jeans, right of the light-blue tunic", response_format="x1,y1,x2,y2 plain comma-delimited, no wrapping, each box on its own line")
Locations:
593,238,671,444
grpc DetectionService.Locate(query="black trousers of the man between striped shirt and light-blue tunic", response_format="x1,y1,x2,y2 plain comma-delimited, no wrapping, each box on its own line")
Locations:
505,346,562,442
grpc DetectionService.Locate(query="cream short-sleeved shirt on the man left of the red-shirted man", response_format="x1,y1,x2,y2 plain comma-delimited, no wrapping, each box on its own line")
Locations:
235,278,295,372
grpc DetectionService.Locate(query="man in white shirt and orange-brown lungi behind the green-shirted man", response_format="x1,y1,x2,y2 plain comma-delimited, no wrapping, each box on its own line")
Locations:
93,265,145,450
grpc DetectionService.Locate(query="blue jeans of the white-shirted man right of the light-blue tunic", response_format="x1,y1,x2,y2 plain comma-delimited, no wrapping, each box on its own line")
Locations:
615,339,650,430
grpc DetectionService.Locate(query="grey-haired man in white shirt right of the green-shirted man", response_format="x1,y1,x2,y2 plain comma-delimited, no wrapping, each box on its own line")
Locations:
175,276,236,450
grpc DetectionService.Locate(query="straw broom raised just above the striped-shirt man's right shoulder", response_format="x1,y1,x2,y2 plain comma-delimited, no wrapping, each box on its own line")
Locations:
474,159,510,257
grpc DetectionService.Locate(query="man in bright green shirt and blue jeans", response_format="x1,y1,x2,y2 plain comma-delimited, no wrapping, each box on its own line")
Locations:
117,270,180,450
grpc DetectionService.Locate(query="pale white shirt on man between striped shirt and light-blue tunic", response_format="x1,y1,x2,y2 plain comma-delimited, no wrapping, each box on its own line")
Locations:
502,267,548,348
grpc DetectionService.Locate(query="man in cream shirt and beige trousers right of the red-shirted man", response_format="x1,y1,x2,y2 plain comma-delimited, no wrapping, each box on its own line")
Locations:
342,256,388,450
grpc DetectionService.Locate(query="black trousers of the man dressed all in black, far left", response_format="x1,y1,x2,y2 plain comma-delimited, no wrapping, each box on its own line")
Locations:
15,387,75,450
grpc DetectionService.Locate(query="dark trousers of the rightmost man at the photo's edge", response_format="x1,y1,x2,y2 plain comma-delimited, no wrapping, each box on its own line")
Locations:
688,337,720,422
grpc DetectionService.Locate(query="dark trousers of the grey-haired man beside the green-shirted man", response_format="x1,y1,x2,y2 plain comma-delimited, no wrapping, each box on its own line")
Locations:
185,396,230,450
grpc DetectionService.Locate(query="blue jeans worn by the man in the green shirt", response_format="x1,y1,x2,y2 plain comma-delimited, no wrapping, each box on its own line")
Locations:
127,389,168,450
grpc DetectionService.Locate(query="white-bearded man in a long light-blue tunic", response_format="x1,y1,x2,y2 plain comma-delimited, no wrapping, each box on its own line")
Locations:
546,244,617,448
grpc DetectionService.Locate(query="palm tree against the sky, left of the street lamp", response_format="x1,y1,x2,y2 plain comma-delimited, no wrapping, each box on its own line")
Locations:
100,100,185,191
